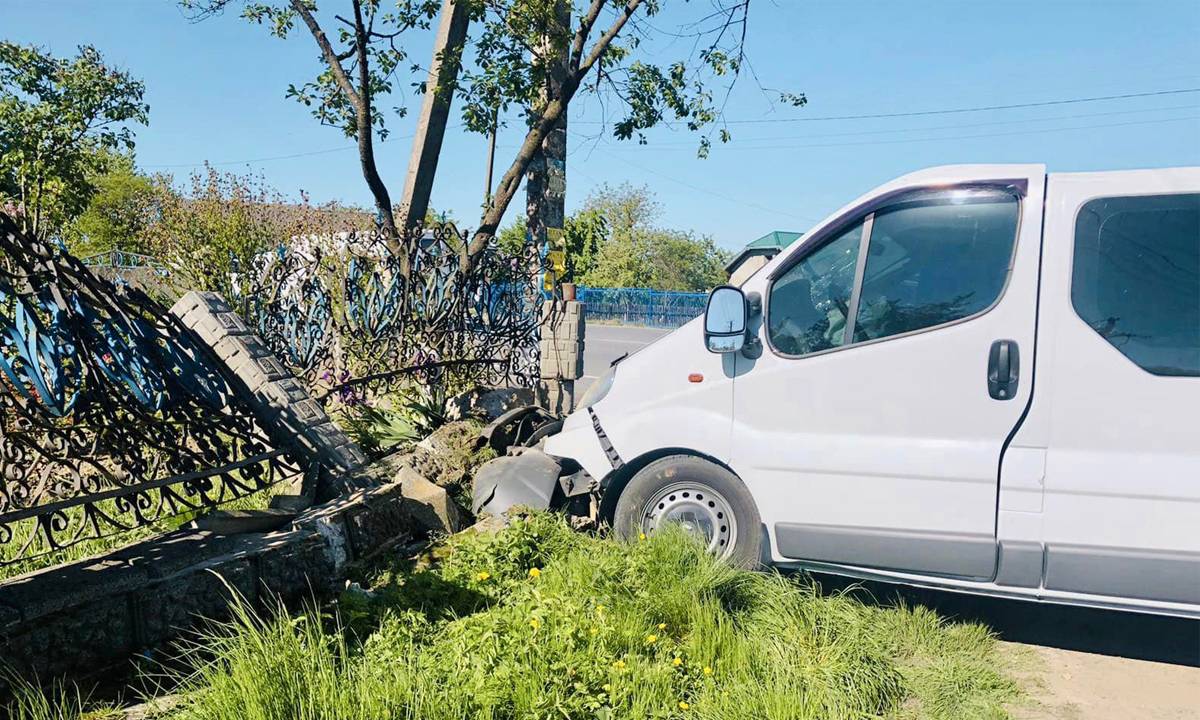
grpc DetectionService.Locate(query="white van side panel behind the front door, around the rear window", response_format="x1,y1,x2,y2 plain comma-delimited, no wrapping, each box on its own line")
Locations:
1030,168,1200,606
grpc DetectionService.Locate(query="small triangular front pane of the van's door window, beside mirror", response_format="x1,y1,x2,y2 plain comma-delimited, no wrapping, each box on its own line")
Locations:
767,222,863,355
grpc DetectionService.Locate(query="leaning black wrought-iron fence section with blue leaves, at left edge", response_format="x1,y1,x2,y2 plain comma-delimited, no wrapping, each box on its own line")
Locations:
0,214,301,565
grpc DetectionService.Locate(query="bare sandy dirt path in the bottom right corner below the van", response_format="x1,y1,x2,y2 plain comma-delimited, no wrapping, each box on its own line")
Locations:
1002,642,1200,720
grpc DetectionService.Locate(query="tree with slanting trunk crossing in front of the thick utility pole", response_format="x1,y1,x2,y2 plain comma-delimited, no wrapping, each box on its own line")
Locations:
461,0,792,268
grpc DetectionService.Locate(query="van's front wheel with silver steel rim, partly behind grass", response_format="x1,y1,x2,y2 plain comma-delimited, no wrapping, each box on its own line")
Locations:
613,455,762,568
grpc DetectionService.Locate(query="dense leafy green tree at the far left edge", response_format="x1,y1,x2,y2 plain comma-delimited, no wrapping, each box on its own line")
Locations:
0,42,150,238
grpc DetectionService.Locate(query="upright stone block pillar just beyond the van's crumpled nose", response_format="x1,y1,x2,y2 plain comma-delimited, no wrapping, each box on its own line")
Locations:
538,300,586,415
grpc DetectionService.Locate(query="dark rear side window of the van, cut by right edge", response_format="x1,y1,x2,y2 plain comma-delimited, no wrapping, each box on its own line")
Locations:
1070,194,1200,377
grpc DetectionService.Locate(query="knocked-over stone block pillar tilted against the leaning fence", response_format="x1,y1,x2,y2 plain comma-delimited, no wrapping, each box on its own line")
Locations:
170,292,367,500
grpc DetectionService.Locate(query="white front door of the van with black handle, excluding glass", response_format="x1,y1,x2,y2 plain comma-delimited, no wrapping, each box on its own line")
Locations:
731,166,1045,580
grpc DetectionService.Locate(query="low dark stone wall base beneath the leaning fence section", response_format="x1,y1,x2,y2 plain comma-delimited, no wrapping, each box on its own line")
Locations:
0,458,420,697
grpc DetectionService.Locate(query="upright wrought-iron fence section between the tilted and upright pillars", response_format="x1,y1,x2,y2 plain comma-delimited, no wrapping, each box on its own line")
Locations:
232,223,542,402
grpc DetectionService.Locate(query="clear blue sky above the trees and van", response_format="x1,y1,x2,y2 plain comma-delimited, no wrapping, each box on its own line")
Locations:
0,0,1200,247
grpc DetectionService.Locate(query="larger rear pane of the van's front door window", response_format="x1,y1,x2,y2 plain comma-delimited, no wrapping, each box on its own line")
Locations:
854,191,1020,342
